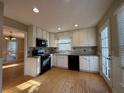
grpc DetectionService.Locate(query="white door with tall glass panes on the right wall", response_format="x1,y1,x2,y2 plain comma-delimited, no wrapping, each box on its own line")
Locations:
101,25,111,80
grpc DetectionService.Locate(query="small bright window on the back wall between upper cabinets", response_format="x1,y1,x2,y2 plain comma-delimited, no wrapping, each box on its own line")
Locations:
58,38,71,51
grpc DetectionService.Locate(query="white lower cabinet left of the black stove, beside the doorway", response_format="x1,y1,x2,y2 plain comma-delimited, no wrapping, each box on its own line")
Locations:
24,57,40,77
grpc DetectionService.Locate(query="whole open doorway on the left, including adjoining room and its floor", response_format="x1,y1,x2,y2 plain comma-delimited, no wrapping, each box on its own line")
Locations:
2,27,31,93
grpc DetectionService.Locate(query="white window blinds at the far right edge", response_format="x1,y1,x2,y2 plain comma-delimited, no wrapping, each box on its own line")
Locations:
117,8,124,67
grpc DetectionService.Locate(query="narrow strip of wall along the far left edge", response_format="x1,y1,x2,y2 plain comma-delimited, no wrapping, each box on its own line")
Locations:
0,2,3,93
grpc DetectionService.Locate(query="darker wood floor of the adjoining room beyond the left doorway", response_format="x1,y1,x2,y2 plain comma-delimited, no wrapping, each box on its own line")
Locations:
2,63,32,93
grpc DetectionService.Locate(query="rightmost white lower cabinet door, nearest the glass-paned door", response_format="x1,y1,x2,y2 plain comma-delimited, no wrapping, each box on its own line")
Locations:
90,56,99,72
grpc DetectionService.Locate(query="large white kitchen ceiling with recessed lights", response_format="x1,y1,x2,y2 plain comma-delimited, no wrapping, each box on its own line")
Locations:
3,0,113,32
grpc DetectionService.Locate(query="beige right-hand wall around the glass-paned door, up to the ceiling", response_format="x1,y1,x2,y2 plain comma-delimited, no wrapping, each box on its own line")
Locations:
97,0,124,93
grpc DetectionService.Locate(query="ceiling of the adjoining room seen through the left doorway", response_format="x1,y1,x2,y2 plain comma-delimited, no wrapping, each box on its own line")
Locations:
3,26,24,38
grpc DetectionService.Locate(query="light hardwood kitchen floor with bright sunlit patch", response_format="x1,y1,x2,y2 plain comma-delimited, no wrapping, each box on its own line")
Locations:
2,68,111,93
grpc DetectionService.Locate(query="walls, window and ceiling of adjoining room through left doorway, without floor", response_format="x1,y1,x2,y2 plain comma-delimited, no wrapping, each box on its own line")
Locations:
2,27,25,64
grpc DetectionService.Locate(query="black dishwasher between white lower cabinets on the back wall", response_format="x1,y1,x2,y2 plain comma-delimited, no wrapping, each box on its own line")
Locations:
68,55,79,71
